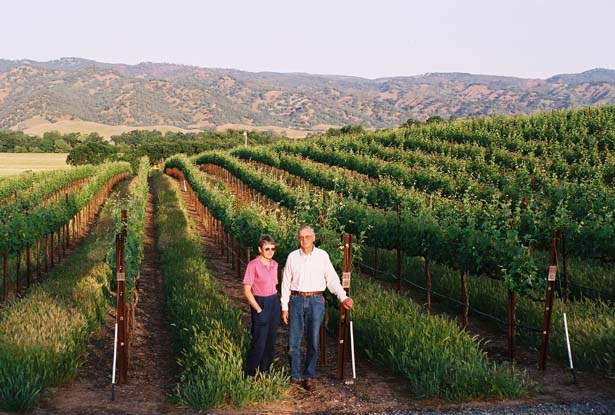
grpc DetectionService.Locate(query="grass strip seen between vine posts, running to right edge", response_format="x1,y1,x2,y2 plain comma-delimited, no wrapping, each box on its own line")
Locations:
366,250,615,374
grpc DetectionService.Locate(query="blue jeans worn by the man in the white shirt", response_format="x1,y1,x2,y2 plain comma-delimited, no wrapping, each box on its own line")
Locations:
288,295,325,380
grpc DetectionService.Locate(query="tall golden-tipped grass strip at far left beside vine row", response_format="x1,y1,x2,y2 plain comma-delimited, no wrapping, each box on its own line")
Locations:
0,185,122,412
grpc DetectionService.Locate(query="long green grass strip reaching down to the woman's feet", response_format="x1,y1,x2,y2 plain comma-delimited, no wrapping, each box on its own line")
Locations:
153,173,288,408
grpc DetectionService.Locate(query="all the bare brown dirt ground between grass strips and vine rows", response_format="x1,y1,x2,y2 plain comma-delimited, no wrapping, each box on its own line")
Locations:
20,176,615,414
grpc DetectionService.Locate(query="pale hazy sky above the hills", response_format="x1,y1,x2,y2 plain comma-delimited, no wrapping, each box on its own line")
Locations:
0,0,615,78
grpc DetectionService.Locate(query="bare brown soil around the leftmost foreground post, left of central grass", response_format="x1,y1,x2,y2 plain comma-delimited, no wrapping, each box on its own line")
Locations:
34,177,184,414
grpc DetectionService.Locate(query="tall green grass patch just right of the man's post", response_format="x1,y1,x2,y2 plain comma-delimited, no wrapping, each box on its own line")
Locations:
330,275,532,401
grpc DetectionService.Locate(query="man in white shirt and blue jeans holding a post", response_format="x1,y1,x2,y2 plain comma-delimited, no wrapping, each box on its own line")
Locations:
281,226,352,390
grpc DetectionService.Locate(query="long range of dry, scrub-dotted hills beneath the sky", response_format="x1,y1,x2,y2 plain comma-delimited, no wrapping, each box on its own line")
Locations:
0,58,615,130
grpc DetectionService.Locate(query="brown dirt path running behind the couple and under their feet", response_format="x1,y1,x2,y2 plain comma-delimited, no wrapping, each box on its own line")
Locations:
168,171,452,413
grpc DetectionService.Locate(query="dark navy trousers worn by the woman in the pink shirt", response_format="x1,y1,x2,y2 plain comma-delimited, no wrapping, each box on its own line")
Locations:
246,294,280,376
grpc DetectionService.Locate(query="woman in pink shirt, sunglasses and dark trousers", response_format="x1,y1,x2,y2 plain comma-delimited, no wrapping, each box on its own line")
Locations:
243,235,280,376
